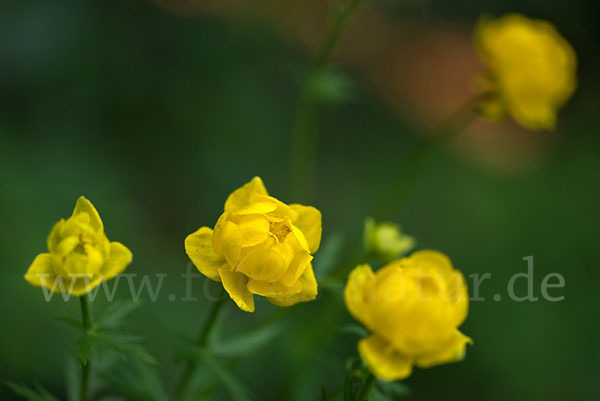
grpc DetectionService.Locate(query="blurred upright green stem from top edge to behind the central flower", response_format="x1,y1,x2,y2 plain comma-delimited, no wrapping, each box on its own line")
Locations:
290,0,364,202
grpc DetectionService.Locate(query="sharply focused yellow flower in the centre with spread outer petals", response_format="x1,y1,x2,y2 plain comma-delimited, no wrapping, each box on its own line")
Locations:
185,177,321,312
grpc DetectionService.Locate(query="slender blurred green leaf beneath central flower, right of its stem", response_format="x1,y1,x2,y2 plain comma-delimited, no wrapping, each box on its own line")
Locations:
210,325,281,357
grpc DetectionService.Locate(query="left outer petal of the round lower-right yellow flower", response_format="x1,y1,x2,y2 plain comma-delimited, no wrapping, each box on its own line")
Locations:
344,265,375,327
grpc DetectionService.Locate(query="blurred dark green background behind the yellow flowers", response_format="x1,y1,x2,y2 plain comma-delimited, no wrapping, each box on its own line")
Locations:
0,0,600,401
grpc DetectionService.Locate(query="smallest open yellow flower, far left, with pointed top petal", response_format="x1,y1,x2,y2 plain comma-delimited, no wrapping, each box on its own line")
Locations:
25,196,132,295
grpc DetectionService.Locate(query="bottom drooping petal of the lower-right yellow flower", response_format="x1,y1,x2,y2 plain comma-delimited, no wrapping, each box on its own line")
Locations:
358,335,413,380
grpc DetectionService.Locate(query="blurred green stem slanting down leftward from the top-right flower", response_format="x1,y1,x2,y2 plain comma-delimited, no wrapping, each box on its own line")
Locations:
371,97,480,219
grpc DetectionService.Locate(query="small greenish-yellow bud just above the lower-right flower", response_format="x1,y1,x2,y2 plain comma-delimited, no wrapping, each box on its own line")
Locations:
364,218,415,261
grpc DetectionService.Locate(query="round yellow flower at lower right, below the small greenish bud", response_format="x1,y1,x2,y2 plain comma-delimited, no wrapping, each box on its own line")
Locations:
344,250,471,380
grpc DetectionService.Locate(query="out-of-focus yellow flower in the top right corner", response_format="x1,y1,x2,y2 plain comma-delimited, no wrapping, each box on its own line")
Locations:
475,14,577,130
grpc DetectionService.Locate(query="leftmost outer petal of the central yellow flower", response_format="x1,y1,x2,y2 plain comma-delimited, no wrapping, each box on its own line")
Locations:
185,227,225,281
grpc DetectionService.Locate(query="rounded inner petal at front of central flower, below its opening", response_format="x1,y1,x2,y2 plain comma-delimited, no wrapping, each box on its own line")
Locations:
236,247,287,282
